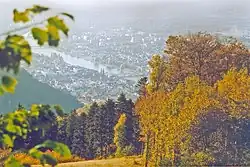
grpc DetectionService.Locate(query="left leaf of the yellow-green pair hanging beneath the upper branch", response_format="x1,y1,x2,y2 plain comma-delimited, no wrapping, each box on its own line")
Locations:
31,27,49,46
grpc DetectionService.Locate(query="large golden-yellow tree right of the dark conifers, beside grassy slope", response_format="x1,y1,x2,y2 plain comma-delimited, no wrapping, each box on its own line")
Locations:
136,77,217,165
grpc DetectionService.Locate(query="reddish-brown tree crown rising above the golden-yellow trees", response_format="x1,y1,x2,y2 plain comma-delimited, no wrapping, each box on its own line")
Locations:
148,33,250,91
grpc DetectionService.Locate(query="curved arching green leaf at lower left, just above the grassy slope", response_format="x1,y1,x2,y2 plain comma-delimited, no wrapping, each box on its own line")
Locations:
35,140,71,157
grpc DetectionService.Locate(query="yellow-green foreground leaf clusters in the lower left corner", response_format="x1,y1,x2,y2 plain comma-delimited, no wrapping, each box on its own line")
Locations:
0,105,71,167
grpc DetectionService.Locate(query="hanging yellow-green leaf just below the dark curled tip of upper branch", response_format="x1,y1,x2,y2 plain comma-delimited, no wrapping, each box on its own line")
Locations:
48,16,69,36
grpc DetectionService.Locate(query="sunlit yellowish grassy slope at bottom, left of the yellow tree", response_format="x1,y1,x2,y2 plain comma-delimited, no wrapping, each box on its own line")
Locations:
34,157,143,167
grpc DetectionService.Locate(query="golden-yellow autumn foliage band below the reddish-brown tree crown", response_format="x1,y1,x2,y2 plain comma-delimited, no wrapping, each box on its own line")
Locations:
135,69,250,164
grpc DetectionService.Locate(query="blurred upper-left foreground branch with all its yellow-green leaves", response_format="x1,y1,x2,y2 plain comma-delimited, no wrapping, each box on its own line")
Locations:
0,5,74,95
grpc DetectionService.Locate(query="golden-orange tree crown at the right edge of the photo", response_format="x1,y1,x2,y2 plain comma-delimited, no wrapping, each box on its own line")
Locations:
215,68,250,118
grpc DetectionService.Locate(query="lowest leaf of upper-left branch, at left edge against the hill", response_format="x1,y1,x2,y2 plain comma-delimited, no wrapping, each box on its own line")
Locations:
2,76,17,93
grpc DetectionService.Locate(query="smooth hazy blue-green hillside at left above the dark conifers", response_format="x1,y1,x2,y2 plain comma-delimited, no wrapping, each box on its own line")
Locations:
0,70,82,114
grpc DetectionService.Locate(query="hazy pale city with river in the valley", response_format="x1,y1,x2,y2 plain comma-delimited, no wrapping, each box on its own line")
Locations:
23,28,164,103
